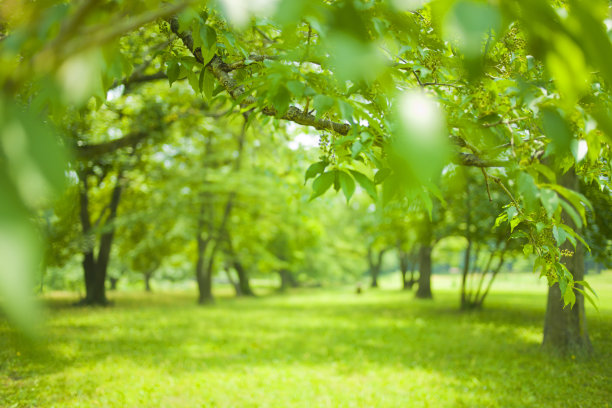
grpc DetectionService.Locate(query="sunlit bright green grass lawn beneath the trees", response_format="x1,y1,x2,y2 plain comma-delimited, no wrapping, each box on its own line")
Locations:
0,272,612,408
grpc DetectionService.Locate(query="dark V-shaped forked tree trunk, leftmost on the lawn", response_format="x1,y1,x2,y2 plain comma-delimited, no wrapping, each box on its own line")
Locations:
79,172,123,306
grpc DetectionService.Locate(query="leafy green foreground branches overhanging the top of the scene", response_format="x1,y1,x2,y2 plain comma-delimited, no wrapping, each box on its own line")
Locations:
0,0,612,356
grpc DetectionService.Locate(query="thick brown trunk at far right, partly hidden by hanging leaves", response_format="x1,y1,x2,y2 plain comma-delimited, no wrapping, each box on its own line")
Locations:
542,168,592,355
